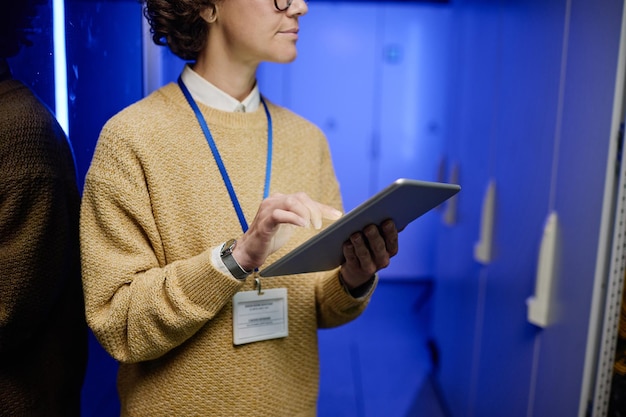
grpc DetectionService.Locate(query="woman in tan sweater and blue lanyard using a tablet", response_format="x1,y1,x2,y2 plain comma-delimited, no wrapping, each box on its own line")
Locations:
81,0,397,416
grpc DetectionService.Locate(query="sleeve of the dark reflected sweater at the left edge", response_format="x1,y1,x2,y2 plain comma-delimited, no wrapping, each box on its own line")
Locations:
0,118,80,355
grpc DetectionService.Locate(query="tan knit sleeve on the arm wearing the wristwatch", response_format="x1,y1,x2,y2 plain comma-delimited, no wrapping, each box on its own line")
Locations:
80,126,242,362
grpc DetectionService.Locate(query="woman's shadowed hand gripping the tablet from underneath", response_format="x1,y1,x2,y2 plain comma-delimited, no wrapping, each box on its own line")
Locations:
341,220,398,289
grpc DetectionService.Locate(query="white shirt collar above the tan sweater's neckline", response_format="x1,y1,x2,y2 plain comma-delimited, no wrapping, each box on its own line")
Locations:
181,65,261,112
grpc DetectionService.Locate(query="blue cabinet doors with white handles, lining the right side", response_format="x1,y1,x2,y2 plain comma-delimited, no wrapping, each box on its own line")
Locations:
432,0,623,417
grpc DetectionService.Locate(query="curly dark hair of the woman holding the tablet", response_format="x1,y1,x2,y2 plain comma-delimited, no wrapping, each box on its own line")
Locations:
143,0,221,61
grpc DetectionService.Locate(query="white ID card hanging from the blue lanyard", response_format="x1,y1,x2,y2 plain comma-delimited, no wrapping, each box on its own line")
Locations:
233,288,289,345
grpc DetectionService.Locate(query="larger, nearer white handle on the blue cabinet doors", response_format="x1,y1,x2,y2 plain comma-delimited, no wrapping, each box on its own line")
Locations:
526,211,559,327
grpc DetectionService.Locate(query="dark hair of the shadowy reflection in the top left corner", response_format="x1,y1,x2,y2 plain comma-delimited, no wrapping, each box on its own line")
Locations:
0,0,48,58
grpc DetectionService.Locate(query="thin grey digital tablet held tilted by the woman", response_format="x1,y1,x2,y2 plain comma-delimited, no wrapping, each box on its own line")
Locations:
260,178,461,277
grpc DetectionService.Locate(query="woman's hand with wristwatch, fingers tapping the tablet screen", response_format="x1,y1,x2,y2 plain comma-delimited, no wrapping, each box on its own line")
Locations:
233,192,342,271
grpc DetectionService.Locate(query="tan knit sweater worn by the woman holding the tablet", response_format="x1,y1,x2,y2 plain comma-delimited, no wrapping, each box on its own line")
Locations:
81,84,374,417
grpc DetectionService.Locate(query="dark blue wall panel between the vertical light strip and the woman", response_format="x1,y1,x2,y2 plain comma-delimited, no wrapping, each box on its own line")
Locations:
65,0,143,189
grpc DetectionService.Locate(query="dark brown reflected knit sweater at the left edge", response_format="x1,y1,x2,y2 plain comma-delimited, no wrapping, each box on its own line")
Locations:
0,79,87,417
